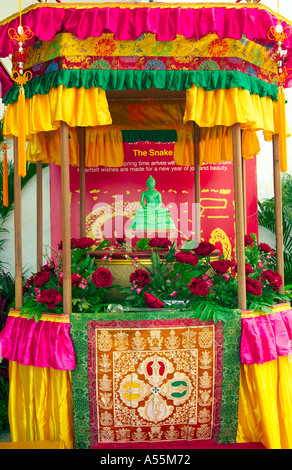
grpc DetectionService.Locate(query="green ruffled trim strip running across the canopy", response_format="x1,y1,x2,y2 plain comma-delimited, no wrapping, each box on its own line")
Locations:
3,69,277,106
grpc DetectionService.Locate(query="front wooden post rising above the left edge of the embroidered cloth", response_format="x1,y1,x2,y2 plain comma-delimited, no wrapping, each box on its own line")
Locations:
60,121,72,314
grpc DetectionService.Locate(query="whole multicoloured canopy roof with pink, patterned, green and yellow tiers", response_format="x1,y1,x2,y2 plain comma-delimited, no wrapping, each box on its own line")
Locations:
0,3,292,171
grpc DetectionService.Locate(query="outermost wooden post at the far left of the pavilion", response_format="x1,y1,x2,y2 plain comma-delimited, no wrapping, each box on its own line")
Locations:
13,137,22,308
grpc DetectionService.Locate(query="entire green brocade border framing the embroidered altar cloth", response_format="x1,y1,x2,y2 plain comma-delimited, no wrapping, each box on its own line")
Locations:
70,310,241,449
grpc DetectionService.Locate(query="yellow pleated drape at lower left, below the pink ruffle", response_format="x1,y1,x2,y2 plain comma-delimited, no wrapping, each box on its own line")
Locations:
8,361,74,449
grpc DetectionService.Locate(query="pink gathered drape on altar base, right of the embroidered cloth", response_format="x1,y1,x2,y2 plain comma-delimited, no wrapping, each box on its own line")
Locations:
240,310,292,364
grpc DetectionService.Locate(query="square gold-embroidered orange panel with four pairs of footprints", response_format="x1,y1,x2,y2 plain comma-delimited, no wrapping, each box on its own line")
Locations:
96,325,215,443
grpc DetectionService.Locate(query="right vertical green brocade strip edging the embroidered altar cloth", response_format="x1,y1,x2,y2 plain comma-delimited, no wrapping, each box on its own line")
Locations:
218,310,241,444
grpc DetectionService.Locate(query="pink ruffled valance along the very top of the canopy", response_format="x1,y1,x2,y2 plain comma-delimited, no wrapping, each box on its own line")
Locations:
0,4,292,87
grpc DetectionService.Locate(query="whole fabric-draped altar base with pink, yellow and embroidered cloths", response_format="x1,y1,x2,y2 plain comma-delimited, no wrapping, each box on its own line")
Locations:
0,304,292,449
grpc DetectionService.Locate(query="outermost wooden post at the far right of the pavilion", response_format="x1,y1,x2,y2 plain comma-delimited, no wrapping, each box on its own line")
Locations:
273,135,284,294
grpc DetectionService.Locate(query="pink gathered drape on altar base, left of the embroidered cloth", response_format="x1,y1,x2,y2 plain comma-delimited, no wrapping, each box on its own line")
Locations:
0,316,75,370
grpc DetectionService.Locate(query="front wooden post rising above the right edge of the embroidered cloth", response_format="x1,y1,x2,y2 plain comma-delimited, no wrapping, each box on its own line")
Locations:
232,123,246,310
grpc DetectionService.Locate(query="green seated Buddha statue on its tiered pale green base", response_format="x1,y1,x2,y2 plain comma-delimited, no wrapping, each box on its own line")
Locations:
129,176,176,236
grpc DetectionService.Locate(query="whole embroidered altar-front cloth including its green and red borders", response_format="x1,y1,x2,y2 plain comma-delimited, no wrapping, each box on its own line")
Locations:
70,310,240,448
